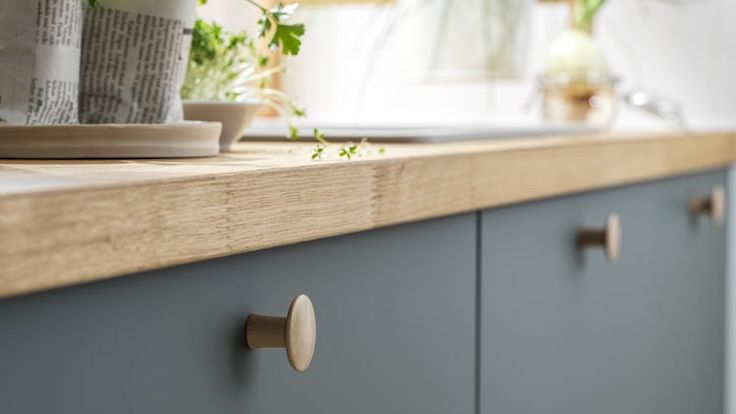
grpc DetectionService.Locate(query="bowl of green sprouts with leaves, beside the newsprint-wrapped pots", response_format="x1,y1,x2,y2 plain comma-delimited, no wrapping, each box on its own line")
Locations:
181,5,305,151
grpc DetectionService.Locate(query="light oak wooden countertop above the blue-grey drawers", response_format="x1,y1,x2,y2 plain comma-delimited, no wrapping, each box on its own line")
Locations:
0,133,736,297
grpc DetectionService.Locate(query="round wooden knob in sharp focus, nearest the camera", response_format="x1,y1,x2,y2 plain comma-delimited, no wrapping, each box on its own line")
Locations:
245,295,317,372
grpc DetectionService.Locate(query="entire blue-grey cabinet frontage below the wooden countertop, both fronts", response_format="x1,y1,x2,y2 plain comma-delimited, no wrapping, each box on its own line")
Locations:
0,163,727,414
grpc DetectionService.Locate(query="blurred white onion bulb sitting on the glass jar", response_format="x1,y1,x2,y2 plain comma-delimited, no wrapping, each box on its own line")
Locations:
547,28,610,82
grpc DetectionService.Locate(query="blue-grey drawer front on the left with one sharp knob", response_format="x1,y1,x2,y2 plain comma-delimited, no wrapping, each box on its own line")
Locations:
0,214,477,414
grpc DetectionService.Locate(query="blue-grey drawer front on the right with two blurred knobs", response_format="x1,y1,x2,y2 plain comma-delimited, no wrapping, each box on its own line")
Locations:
480,172,726,414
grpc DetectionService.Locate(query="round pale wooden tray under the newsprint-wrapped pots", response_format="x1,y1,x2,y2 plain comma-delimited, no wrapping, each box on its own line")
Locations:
0,121,222,159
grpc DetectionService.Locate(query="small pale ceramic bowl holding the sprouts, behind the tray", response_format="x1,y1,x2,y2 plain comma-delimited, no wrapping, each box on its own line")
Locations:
184,101,263,151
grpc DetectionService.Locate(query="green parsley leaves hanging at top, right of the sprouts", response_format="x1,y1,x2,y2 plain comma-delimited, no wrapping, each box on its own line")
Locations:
258,4,306,56
